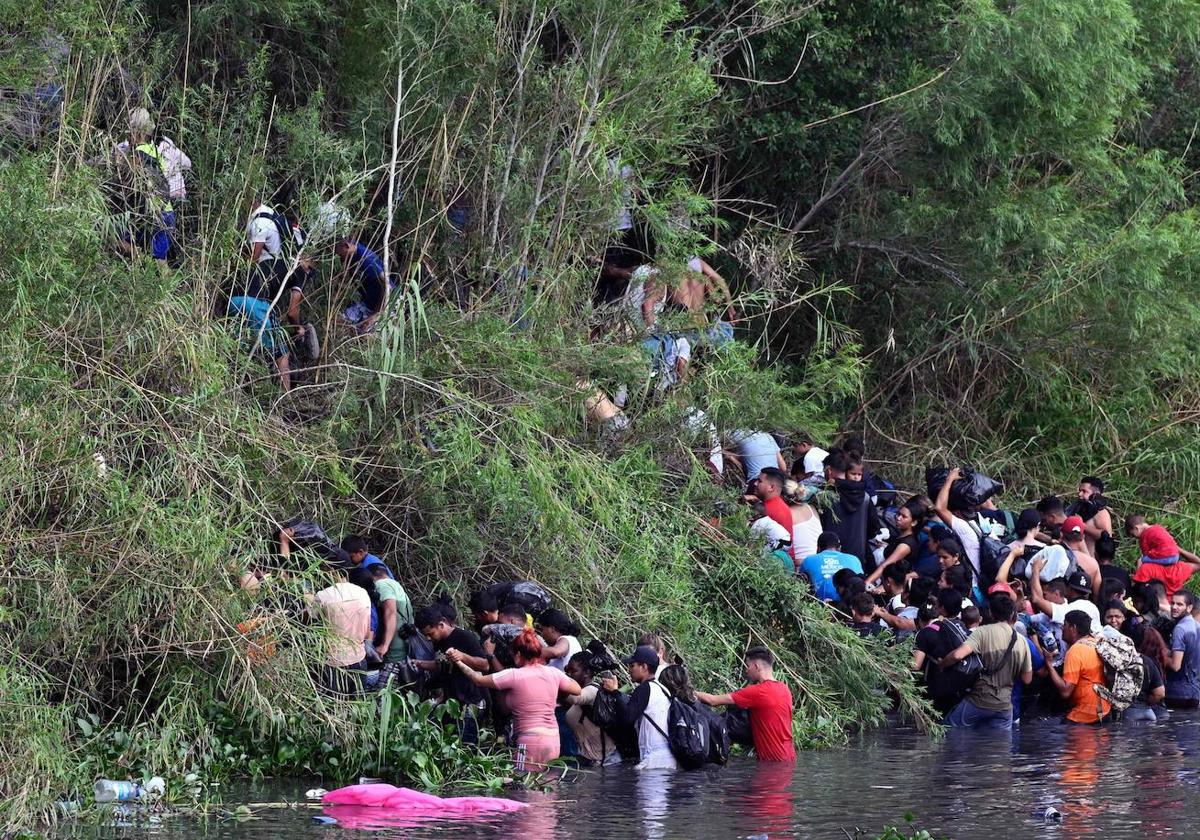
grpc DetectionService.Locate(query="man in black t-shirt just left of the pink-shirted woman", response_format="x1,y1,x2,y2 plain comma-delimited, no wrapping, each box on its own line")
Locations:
413,604,488,744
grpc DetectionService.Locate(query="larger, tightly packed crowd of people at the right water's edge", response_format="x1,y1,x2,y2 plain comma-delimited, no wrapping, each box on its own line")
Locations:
734,432,1200,728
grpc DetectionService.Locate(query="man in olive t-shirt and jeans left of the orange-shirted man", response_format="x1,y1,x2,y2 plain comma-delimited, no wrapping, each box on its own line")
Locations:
940,593,1033,730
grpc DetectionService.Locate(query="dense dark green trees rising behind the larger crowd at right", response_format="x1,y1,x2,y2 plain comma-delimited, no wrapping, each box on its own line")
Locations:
726,0,1200,541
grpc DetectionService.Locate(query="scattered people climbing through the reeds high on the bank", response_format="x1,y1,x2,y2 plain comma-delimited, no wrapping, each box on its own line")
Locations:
108,108,734,403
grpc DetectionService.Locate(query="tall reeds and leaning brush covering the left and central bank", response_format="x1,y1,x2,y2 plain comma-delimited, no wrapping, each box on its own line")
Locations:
0,0,907,829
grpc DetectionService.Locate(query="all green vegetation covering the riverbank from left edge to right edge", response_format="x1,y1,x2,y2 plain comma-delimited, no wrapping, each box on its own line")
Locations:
0,0,1200,833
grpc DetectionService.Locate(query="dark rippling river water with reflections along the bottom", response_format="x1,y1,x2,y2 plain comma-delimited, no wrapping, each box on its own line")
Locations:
72,713,1200,840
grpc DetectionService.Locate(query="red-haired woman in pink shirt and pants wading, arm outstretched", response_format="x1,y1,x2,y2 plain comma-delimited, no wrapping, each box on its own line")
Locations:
446,628,580,773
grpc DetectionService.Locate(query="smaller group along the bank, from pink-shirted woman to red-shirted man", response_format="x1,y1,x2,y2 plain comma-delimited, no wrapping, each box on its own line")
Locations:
242,522,796,772
